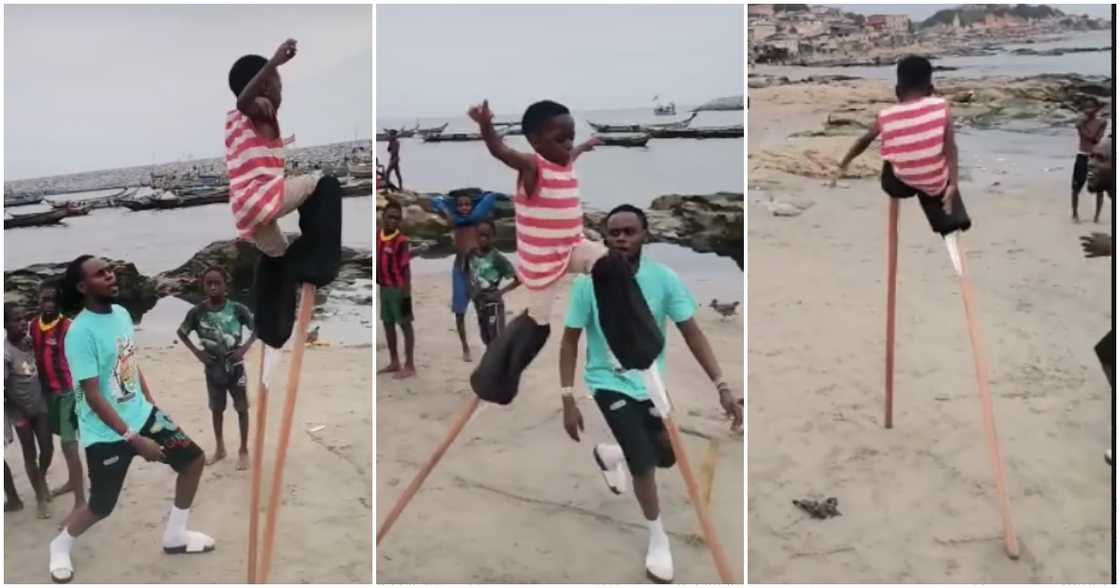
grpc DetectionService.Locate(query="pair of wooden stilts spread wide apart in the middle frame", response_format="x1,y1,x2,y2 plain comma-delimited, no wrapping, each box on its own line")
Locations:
377,366,735,584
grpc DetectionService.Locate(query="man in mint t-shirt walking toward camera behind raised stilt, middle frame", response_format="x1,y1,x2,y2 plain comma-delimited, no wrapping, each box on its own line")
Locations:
560,205,743,582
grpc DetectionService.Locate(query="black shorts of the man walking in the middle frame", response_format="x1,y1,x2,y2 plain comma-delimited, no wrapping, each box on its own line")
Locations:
595,390,676,476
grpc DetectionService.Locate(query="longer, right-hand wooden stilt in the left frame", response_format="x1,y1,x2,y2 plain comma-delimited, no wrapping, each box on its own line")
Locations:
259,283,315,584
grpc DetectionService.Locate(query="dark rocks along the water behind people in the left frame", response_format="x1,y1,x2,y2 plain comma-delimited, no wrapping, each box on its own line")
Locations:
3,235,373,324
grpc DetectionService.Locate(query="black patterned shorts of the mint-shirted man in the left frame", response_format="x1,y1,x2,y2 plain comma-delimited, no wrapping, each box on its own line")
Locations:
85,408,203,517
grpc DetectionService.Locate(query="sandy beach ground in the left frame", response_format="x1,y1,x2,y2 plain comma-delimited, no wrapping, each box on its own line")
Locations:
4,344,372,584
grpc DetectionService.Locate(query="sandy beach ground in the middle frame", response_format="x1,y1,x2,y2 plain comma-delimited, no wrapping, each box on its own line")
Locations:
376,272,744,584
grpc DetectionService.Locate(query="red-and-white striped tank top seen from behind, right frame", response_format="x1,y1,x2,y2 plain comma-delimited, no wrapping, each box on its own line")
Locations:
879,96,949,196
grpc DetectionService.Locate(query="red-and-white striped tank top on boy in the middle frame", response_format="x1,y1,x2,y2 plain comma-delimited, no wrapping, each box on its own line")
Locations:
513,153,584,290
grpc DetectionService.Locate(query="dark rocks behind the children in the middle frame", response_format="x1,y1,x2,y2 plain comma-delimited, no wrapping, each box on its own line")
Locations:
377,188,744,268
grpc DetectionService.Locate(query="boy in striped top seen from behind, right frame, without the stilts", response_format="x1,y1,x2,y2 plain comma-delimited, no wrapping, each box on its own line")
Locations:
837,56,972,235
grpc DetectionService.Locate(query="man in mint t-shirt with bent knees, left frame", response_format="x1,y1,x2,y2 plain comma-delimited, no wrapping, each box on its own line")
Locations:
49,255,214,582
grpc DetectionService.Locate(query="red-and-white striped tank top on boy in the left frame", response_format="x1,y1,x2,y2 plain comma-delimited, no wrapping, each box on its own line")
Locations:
225,110,283,239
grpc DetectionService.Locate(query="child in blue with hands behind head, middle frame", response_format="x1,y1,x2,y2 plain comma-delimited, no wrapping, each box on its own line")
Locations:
432,193,497,362
